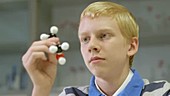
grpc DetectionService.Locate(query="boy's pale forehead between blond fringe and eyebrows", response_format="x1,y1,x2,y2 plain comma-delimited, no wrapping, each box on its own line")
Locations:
78,16,117,35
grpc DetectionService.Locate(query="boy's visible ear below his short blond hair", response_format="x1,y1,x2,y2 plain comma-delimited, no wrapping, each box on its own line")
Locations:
127,37,139,57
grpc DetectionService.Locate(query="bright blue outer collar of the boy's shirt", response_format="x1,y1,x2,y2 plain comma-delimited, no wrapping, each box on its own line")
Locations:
89,69,144,96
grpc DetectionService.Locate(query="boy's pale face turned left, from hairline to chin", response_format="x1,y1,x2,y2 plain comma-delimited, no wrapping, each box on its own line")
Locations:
78,17,129,78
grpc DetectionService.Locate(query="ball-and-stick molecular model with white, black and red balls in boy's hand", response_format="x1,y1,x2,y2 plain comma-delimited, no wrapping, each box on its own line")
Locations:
40,26,69,65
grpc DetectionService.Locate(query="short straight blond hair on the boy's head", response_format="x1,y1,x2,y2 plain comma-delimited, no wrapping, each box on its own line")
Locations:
80,1,139,66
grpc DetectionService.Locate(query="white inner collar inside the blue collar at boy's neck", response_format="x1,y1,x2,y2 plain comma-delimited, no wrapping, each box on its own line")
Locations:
95,70,133,96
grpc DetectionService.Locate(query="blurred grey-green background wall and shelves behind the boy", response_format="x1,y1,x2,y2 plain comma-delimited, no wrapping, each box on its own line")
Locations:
0,0,170,96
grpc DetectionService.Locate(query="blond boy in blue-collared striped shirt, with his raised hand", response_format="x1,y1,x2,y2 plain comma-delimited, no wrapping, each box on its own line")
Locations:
22,2,170,96
